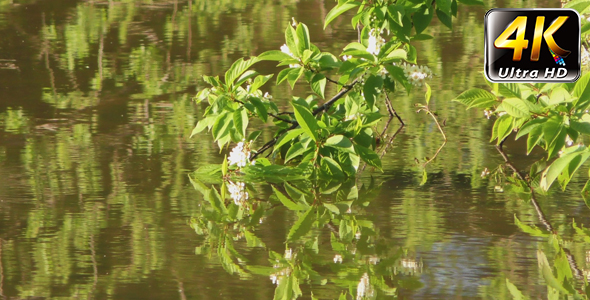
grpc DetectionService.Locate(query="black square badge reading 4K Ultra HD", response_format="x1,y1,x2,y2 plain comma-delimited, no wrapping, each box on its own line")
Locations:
485,8,581,82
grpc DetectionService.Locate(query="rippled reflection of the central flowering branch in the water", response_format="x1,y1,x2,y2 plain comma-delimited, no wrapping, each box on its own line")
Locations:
191,173,412,300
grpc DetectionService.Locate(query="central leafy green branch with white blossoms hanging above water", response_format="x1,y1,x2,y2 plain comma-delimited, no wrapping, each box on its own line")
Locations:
191,0,478,178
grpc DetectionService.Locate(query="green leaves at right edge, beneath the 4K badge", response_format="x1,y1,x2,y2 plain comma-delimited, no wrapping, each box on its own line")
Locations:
454,1,590,193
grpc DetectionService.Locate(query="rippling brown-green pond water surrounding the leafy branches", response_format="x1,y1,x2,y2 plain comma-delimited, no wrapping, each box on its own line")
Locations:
0,0,590,299
